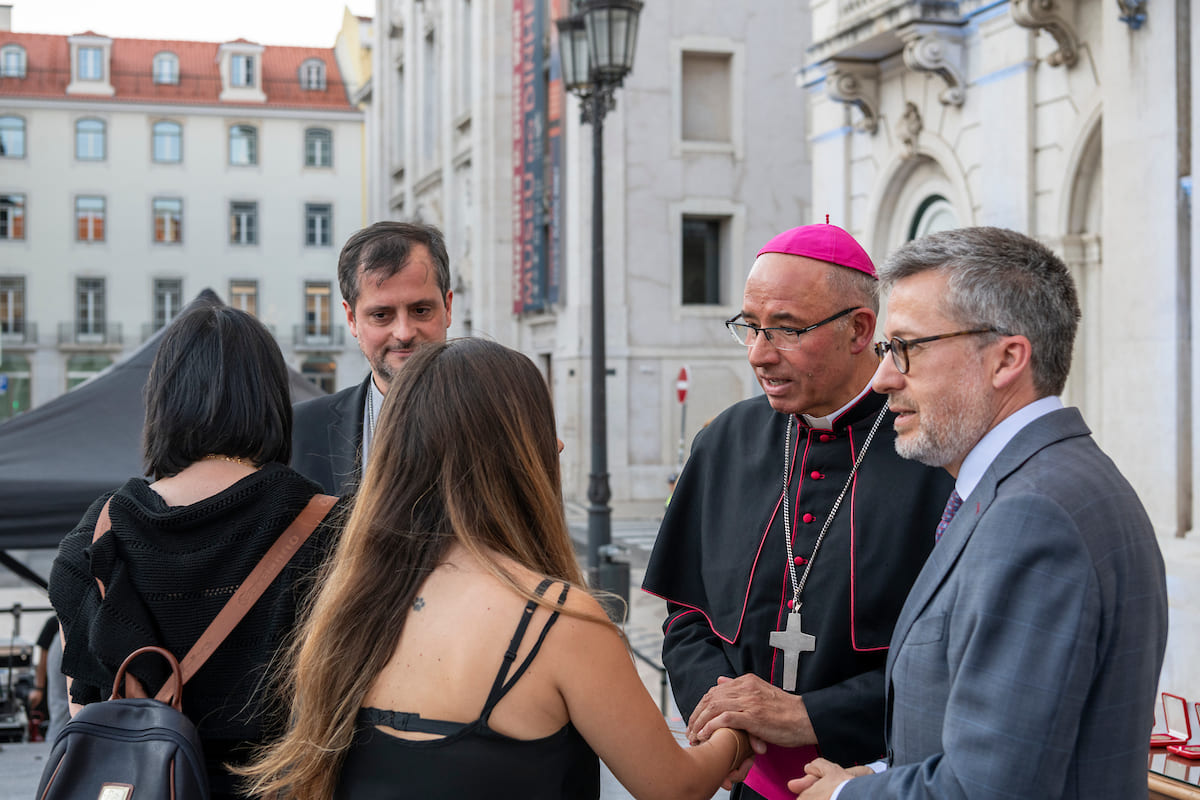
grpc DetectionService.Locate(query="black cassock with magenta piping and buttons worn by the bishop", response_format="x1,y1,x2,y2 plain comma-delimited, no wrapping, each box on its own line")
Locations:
642,225,953,798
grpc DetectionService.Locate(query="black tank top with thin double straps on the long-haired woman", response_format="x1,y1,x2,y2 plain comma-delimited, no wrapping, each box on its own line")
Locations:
334,581,600,800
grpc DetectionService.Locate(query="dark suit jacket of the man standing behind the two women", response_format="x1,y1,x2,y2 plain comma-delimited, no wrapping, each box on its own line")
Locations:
292,373,371,497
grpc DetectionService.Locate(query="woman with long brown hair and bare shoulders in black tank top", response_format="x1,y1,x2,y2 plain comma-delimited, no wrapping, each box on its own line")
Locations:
237,338,750,800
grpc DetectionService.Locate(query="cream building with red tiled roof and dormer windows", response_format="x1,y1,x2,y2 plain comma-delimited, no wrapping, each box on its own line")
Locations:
0,8,364,420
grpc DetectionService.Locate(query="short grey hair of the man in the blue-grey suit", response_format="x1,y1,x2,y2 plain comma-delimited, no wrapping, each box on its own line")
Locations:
880,228,1080,397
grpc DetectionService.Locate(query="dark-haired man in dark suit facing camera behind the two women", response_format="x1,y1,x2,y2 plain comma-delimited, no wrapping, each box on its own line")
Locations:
292,222,454,495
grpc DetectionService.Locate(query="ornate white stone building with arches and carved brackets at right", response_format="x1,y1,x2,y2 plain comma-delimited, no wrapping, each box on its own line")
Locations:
798,0,1200,697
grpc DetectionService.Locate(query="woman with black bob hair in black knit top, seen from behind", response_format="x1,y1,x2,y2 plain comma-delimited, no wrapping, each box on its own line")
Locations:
50,301,338,798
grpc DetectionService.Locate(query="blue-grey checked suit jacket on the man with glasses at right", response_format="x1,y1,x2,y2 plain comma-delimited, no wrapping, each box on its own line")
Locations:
841,409,1166,800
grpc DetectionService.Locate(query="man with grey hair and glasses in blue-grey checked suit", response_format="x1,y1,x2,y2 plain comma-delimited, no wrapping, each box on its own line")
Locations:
788,228,1166,800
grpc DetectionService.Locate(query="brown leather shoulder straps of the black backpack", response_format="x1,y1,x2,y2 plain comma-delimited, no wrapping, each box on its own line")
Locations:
91,494,337,703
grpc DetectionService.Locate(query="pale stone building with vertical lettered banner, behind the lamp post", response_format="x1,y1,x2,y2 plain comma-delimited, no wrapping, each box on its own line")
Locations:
368,0,814,512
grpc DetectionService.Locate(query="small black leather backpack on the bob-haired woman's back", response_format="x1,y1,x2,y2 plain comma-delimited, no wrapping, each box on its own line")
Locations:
37,646,209,800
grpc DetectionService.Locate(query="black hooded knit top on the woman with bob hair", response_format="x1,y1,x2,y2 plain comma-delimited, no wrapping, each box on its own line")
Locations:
50,464,342,796
